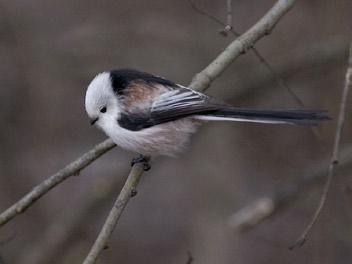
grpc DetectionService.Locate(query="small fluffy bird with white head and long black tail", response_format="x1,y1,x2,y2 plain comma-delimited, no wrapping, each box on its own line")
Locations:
85,69,330,169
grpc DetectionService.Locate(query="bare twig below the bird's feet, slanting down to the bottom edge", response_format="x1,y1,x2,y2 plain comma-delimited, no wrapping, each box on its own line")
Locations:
83,163,144,264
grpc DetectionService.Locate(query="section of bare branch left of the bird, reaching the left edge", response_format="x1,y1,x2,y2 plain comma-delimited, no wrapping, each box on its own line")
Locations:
0,139,116,227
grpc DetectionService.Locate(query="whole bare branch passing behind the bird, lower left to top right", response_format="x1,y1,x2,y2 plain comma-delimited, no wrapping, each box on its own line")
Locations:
0,0,295,227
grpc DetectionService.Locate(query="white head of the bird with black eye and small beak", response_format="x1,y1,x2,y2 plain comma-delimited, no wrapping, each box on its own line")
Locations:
85,72,118,129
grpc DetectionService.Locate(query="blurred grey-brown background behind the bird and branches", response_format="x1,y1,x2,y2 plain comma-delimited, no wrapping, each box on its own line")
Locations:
0,0,352,264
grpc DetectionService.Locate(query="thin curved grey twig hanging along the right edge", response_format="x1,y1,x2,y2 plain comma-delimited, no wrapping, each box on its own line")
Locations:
289,42,352,249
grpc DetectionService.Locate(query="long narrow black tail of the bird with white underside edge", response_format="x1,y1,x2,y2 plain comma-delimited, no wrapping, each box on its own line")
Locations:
197,107,330,125
